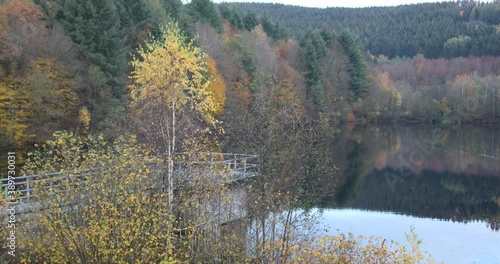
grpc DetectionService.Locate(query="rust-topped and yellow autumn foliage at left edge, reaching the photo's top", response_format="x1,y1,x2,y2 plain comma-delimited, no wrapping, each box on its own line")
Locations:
0,0,80,145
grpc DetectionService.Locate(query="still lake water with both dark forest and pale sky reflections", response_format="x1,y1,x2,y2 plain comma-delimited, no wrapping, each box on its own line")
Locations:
318,125,500,263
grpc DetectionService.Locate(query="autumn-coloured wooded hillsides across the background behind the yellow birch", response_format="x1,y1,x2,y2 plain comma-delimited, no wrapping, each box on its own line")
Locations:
0,0,500,151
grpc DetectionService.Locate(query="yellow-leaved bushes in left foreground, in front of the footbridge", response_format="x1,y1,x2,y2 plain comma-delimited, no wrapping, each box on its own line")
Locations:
18,132,173,263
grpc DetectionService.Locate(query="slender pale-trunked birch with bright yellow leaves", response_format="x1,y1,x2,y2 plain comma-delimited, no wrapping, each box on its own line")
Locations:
130,22,217,209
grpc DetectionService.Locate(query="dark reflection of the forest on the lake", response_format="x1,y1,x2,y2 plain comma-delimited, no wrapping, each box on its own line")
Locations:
318,125,500,231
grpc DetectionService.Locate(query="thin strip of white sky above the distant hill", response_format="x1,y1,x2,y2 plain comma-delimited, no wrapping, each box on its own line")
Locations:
213,0,484,8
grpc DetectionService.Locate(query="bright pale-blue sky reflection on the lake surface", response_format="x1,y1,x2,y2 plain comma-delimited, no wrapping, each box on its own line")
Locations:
323,209,500,264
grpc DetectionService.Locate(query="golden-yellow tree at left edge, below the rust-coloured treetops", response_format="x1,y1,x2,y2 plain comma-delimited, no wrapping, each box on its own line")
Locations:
0,57,79,144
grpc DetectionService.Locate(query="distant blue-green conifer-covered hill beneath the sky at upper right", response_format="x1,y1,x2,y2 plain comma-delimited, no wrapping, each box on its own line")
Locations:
230,0,500,58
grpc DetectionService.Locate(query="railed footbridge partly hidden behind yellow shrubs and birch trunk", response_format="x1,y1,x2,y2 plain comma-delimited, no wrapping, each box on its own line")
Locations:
2,152,260,215
